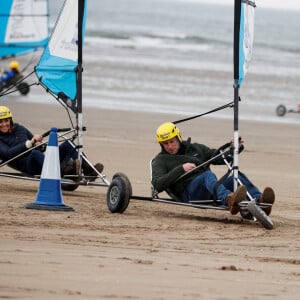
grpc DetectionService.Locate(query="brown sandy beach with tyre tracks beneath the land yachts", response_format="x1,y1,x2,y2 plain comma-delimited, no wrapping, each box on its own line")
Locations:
0,100,300,300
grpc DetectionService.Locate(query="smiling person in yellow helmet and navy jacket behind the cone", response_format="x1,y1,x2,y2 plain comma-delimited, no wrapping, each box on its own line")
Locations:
0,106,103,177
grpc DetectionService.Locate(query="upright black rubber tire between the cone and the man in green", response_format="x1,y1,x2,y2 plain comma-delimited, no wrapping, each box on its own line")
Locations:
106,176,132,214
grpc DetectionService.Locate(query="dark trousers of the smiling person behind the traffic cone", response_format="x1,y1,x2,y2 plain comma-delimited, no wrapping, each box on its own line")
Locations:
26,142,78,175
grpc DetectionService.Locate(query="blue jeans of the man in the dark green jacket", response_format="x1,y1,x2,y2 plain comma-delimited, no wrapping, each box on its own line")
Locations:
183,171,261,204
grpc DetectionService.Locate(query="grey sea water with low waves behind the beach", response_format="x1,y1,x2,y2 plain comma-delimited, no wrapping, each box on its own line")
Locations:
25,0,300,123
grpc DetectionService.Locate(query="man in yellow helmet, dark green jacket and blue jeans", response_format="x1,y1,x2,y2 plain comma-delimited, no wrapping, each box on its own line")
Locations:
152,122,275,215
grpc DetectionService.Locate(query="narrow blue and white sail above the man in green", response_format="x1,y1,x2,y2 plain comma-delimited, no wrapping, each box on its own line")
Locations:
234,0,256,87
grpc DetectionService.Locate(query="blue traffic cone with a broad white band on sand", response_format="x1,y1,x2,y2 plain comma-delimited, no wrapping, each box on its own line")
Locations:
25,128,74,211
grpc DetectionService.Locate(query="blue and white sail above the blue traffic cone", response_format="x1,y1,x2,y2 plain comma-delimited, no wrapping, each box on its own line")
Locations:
35,0,87,110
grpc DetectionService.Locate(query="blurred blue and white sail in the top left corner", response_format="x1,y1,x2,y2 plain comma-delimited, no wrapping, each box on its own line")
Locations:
0,0,49,58
